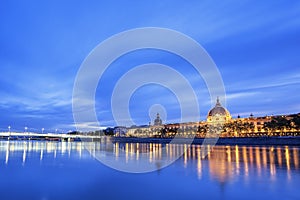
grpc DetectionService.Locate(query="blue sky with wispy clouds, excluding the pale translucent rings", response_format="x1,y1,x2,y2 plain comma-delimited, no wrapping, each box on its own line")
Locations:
0,1,300,131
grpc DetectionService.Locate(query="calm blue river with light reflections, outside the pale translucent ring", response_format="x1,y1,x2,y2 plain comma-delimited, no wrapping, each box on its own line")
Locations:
0,141,300,200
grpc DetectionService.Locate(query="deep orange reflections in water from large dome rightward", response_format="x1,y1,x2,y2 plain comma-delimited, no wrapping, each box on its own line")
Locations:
204,146,299,182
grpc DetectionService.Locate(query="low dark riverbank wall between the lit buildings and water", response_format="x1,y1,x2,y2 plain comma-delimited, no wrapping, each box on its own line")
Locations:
111,137,300,146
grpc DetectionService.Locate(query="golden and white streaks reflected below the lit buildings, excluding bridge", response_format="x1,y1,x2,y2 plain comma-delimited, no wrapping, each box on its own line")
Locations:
106,143,299,182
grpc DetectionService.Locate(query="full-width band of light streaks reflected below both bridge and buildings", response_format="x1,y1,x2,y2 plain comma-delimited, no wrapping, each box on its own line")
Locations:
0,141,299,183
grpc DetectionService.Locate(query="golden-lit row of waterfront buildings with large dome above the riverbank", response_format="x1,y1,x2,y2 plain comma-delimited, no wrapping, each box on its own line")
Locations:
111,98,300,137
